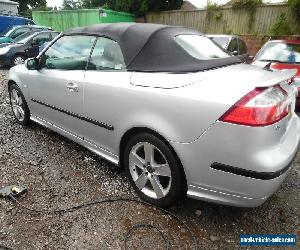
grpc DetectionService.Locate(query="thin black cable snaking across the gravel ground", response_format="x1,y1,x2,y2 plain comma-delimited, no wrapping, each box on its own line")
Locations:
7,194,198,250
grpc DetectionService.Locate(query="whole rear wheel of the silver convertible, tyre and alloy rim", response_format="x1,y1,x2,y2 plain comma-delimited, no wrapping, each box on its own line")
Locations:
123,133,186,207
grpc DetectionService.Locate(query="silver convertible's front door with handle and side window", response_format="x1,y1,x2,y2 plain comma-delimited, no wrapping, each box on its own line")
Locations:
28,35,96,137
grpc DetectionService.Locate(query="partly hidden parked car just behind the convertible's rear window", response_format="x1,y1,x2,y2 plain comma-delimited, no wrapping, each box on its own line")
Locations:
206,35,251,63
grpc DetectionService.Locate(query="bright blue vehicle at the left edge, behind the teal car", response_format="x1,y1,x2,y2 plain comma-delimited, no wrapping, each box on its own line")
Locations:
0,15,35,35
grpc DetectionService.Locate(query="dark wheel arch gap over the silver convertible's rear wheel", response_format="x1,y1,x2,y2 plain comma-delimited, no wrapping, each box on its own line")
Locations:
119,127,187,187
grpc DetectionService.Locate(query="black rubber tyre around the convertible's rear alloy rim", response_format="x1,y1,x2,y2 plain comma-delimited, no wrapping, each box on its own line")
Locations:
123,133,186,207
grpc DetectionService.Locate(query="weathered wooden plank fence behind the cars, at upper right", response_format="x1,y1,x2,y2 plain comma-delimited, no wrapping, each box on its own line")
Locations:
146,4,300,35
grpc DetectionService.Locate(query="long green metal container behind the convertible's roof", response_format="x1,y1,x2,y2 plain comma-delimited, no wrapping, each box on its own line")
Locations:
32,9,135,31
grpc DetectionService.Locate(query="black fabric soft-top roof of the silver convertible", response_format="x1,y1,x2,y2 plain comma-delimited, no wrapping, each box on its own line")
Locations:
64,23,240,72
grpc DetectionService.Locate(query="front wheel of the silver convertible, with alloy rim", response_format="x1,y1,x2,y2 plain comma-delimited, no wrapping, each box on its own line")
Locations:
9,84,30,126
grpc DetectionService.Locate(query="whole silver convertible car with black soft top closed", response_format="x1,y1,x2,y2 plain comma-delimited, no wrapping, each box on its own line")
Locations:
8,23,300,207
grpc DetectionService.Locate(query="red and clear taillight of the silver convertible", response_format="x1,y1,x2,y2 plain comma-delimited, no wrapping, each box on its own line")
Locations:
219,85,290,126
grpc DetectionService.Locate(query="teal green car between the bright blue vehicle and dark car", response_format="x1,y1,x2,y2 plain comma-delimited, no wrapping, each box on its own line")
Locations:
0,25,52,44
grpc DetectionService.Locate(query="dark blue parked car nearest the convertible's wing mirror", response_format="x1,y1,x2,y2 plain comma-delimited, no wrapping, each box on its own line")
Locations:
0,31,59,66
